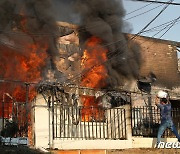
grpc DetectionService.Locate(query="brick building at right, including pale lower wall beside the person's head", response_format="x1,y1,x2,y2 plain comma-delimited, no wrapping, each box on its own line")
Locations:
126,36,180,107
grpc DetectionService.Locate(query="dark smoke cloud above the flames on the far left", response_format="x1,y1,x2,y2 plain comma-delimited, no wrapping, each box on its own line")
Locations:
0,0,61,80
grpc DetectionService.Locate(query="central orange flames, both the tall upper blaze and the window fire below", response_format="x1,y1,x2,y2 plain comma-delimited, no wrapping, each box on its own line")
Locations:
81,36,108,121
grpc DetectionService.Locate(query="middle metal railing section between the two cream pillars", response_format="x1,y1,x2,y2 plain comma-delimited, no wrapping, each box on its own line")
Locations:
52,104,126,140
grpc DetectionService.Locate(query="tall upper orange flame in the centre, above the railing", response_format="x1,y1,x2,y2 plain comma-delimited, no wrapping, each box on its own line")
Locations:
81,36,107,88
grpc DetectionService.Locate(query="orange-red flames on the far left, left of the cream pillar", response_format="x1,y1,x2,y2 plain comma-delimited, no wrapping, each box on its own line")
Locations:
0,17,48,140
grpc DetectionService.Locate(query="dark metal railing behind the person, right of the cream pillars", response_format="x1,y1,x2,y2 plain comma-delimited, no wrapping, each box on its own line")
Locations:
131,106,180,137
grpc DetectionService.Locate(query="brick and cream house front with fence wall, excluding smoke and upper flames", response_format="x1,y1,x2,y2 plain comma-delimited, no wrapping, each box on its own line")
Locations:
29,22,180,149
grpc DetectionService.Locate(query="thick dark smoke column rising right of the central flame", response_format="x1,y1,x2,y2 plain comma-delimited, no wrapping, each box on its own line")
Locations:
75,0,141,86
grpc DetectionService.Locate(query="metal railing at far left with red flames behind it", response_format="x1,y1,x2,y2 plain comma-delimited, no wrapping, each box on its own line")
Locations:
0,101,28,137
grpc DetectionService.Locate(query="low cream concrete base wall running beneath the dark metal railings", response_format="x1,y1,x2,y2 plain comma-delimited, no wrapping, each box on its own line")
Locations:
51,137,177,150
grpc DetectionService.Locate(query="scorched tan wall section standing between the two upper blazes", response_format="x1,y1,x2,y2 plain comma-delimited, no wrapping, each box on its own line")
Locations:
55,22,81,84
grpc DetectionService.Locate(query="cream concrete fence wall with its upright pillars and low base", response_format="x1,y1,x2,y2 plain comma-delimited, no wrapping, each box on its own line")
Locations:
34,95,177,150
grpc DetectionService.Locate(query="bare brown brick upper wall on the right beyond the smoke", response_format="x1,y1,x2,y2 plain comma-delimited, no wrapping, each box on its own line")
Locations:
131,36,180,88
